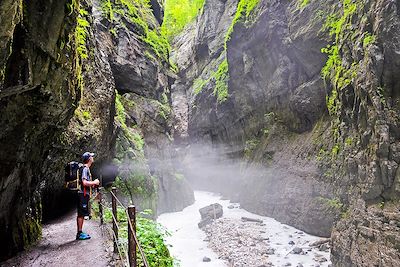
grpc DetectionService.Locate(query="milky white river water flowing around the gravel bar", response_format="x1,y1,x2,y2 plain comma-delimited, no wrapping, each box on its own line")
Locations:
157,191,330,267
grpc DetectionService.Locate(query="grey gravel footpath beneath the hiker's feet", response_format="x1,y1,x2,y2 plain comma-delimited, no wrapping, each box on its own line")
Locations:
0,211,112,267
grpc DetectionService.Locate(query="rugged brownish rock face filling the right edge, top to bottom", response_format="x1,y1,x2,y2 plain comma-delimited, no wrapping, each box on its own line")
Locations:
320,1,400,266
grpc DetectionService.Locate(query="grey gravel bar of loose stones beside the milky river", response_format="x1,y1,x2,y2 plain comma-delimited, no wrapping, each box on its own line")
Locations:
204,218,329,267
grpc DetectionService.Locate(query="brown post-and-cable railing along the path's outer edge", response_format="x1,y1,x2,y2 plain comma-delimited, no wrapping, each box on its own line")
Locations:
99,187,149,267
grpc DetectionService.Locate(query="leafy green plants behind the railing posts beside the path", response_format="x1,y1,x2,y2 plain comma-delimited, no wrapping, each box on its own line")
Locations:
99,205,174,267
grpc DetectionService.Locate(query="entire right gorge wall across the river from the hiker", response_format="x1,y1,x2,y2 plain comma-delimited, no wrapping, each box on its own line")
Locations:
172,0,400,266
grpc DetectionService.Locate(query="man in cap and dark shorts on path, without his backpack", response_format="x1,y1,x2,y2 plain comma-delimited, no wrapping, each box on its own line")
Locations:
76,152,100,240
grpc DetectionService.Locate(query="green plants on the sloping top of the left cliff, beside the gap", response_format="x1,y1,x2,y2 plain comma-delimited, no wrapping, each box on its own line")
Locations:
101,0,170,62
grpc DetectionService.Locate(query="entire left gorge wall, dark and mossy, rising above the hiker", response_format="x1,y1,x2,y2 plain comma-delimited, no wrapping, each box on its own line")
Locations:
0,0,193,260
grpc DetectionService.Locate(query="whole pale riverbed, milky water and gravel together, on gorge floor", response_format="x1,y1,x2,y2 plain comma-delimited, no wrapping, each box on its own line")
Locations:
157,191,331,267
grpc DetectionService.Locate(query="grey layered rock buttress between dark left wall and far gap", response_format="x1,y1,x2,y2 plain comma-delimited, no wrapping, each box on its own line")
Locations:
98,0,194,213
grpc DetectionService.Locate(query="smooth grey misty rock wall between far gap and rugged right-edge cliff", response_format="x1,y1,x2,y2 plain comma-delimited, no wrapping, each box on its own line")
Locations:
172,1,334,236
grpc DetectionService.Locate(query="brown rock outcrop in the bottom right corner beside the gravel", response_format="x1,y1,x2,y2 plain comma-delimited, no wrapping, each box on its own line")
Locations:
331,200,400,266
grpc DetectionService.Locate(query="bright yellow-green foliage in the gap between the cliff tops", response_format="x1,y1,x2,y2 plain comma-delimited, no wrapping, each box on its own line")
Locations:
161,0,205,41
